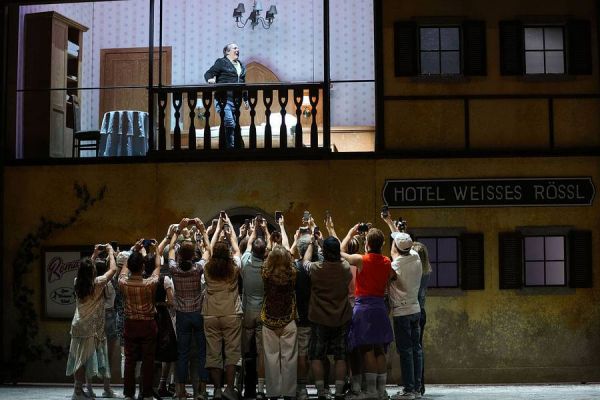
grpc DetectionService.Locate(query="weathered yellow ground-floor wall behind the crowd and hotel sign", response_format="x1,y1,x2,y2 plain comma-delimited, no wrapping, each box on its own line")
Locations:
3,158,600,383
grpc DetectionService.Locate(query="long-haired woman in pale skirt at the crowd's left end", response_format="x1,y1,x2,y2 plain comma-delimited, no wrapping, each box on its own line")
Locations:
66,244,117,400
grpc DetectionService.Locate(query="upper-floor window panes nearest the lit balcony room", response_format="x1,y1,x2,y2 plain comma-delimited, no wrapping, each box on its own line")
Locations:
419,27,460,75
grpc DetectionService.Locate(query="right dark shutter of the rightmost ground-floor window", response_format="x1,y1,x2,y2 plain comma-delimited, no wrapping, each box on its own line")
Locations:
569,231,592,288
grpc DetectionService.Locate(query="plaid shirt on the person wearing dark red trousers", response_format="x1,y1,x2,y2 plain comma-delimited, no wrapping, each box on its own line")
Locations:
119,273,158,320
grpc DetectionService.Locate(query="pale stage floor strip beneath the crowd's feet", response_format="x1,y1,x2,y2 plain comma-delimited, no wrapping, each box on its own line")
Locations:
0,383,600,400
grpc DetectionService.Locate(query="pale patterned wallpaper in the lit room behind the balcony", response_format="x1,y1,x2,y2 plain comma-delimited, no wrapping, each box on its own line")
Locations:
20,0,375,136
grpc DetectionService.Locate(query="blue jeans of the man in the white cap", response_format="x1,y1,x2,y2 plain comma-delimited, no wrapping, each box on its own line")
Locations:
394,312,423,392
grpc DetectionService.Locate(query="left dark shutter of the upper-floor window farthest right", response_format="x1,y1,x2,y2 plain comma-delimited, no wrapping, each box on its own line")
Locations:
499,21,525,75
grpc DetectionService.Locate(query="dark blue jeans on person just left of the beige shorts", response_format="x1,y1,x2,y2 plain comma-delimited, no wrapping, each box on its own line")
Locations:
176,311,208,383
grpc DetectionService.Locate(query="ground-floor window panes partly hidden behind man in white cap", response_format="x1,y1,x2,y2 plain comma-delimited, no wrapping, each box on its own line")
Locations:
418,237,458,288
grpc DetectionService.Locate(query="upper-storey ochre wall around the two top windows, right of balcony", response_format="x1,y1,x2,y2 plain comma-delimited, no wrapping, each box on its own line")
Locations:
382,0,600,150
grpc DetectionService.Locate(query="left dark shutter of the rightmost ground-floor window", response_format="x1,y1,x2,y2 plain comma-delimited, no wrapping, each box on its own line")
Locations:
498,232,523,289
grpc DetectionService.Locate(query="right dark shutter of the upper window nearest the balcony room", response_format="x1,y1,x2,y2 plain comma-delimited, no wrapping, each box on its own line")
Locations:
462,21,487,75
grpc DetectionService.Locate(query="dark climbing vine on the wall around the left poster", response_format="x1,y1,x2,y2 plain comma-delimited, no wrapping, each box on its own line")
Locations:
4,182,107,382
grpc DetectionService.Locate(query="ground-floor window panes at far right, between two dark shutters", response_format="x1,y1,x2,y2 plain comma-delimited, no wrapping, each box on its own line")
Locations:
523,236,567,286
